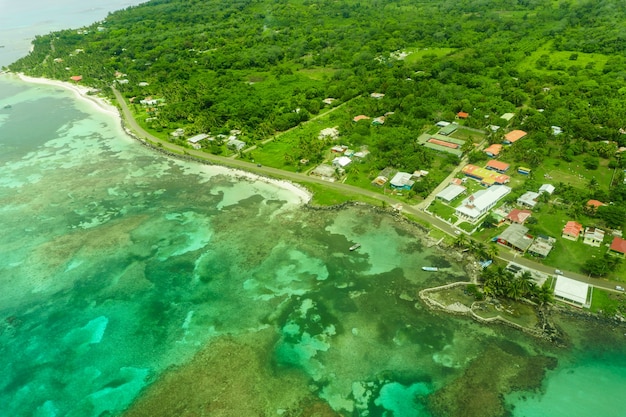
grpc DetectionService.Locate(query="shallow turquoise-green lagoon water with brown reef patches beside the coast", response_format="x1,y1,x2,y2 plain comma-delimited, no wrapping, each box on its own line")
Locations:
0,77,626,417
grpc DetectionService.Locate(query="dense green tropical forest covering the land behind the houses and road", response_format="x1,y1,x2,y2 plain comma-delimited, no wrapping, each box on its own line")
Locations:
10,0,626,201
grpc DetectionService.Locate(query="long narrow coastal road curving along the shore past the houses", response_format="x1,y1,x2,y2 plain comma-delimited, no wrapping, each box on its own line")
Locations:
112,88,620,291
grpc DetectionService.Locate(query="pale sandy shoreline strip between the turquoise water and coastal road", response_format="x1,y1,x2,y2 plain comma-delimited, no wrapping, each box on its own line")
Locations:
4,72,313,205
